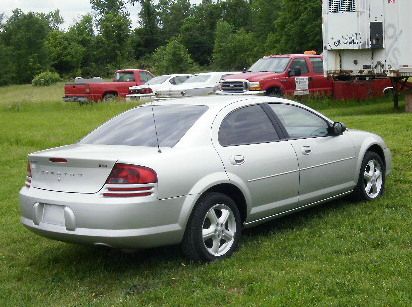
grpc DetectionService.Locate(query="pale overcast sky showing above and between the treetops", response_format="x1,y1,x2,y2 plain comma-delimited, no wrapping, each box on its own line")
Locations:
0,0,201,29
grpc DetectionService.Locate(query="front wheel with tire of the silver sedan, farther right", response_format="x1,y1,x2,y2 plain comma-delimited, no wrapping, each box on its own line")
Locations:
352,151,385,201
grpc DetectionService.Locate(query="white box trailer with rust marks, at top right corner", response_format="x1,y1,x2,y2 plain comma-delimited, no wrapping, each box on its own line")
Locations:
322,0,412,78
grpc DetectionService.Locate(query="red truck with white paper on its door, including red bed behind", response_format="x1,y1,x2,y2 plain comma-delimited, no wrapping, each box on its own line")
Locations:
218,53,391,99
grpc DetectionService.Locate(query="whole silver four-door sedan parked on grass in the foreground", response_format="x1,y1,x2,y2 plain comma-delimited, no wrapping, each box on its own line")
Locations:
20,96,391,261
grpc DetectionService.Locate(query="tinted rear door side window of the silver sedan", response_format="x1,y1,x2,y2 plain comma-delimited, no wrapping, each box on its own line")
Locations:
219,105,279,146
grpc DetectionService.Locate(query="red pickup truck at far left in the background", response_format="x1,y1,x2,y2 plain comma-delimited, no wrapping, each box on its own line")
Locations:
63,69,153,103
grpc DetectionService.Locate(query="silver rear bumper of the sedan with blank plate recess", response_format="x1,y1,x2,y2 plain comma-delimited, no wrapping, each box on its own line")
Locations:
20,187,184,248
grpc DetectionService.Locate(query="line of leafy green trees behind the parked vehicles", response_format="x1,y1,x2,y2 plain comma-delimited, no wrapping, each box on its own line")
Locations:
0,0,322,85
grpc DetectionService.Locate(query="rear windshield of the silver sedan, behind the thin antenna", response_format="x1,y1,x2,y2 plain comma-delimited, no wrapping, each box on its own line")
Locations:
80,105,208,147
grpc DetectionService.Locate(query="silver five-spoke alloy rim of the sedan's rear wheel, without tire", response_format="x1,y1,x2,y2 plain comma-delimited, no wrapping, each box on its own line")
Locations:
202,204,236,256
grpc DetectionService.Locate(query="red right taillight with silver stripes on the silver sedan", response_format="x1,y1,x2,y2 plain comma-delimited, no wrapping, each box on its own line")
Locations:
103,163,157,197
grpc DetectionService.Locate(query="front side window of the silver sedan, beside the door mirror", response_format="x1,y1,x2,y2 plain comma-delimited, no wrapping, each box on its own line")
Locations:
270,104,329,138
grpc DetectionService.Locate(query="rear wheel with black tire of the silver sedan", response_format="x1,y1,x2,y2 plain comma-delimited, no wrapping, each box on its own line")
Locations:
182,192,241,262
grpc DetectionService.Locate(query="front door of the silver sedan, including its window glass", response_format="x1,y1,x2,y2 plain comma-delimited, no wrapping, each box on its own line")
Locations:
270,103,356,205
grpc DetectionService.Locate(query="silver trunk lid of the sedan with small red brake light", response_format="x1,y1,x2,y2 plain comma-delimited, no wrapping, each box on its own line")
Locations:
29,144,156,194
